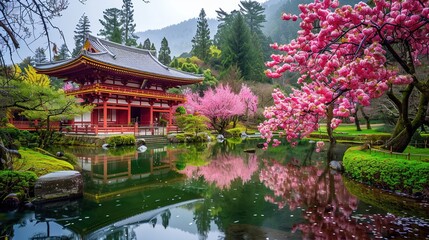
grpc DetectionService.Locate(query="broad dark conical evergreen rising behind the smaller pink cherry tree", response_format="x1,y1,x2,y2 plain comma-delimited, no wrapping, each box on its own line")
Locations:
221,13,264,80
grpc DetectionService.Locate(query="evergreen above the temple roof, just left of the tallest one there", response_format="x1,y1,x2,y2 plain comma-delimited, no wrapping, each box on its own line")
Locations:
98,8,122,43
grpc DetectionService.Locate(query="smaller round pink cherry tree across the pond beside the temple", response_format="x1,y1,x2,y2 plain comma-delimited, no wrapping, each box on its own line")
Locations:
185,84,258,134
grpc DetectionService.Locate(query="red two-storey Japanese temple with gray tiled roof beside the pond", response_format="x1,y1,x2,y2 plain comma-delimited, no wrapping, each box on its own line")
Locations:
36,35,203,134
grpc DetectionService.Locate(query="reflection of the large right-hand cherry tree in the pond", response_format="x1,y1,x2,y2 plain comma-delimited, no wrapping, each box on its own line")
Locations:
260,158,429,239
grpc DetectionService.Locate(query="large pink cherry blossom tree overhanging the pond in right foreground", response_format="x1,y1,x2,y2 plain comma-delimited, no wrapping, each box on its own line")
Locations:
259,0,429,151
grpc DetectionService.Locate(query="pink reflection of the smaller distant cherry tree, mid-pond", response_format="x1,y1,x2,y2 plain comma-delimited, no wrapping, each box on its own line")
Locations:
180,154,258,189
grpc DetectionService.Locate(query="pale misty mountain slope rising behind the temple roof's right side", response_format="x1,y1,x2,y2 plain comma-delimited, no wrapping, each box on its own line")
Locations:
136,18,218,57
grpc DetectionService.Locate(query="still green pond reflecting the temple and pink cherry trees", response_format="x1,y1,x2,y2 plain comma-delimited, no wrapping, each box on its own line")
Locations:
0,141,429,240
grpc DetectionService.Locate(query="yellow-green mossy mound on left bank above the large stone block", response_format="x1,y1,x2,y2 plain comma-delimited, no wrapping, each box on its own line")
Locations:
13,148,74,176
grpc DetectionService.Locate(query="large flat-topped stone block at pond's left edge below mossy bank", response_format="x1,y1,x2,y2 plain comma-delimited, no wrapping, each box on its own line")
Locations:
34,171,83,202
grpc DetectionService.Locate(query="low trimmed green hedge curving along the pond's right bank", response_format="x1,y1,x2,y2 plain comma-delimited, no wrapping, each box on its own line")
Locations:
343,147,429,196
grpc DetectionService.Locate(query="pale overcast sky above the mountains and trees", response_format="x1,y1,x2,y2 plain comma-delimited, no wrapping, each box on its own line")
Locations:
15,0,267,62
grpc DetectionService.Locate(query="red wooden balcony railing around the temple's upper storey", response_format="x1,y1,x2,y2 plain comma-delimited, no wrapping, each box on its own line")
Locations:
66,83,185,101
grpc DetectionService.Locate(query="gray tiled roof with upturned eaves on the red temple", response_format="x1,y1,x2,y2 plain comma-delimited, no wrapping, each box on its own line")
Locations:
36,35,203,80
